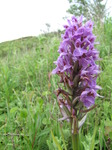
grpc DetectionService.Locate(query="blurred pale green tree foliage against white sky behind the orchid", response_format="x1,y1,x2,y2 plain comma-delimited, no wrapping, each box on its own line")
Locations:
67,0,107,21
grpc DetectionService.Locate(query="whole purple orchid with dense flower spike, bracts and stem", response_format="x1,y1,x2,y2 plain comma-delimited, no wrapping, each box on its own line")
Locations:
52,16,101,150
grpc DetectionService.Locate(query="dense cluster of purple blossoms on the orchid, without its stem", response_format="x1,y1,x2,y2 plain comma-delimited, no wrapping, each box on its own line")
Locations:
52,16,101,108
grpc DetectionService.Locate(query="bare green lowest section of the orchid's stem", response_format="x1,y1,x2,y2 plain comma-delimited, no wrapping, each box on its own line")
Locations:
72,133,79,150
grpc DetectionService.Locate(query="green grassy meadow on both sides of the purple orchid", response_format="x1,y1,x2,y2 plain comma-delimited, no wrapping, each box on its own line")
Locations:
0,18,112,150
